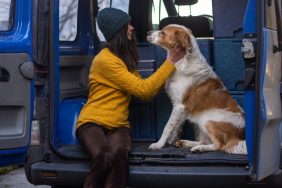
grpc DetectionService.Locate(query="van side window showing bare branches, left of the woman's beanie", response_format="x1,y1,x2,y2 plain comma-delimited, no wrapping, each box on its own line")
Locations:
59,0,78,41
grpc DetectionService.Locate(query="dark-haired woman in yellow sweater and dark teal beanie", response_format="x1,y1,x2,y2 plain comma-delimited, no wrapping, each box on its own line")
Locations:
76,8,184,188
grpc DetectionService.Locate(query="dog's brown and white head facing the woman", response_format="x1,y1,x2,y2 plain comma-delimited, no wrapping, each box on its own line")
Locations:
147,24,194,52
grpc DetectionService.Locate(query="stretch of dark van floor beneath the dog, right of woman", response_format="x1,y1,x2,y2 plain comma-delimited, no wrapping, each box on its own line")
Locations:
130,142,248,165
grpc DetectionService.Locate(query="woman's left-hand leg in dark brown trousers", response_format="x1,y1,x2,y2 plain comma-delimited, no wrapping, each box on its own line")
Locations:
77,124,112,188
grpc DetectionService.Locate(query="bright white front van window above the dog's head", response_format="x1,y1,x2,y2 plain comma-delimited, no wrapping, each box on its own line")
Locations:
152,0,212,29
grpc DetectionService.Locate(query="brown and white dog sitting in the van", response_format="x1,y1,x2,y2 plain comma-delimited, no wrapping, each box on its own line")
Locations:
147,24,247,154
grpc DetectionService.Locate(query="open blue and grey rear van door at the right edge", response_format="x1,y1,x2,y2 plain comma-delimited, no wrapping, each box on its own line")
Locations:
253,0,282,180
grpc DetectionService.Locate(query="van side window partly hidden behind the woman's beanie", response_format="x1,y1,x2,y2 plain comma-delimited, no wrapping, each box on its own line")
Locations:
96,0,129,41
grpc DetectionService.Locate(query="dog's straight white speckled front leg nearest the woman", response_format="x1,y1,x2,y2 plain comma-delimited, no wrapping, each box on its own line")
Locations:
149,105,186,149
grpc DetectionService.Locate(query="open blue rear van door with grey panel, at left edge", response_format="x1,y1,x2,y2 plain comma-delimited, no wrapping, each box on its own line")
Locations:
0,0,34,166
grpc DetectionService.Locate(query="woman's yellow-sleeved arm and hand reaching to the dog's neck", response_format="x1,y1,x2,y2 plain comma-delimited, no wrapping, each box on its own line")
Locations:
93,48,185,100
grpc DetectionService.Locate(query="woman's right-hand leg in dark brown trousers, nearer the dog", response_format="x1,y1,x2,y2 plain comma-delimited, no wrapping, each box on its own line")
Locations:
105,127,131,188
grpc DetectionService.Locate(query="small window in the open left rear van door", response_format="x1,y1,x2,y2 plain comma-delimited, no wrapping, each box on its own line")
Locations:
0,0,14,31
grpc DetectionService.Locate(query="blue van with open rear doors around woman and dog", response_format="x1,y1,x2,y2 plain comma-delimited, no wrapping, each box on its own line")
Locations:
0,0,282,188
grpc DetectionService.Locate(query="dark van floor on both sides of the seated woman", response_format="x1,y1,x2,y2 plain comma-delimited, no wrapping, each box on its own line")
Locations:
57,141,248,165
